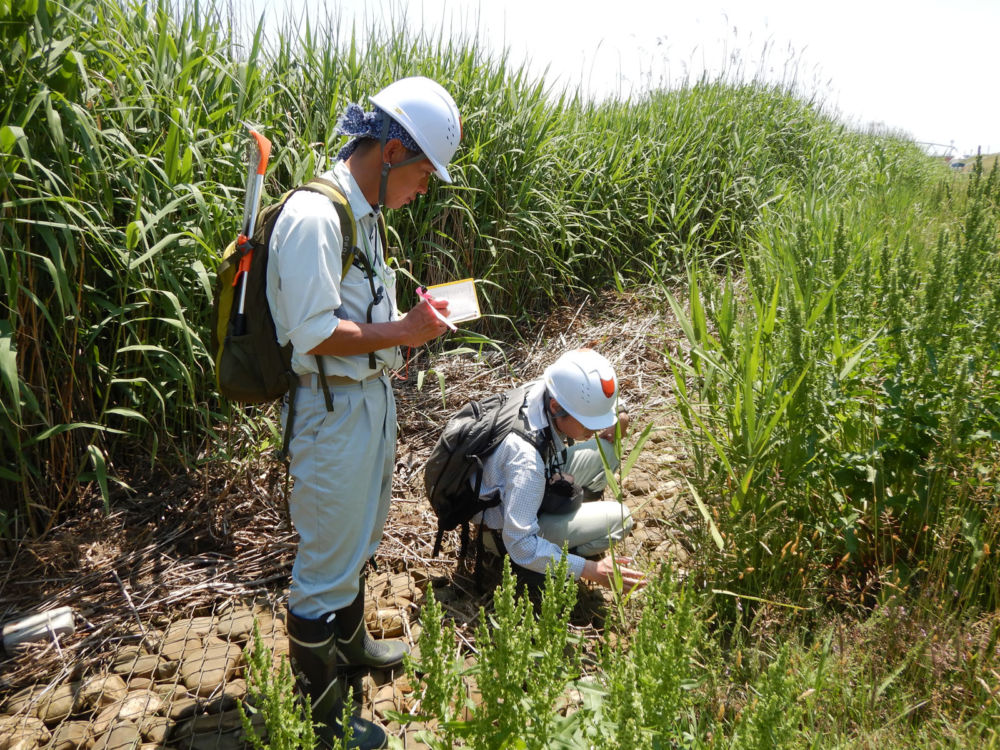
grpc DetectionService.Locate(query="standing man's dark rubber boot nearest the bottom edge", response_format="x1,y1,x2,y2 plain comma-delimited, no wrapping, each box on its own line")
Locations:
288,610,386,750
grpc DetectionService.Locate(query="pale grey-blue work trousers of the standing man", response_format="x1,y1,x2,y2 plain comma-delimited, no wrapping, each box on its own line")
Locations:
281,375,396,619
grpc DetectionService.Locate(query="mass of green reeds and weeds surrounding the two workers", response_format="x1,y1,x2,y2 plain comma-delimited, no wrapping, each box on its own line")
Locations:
0,2,1000,747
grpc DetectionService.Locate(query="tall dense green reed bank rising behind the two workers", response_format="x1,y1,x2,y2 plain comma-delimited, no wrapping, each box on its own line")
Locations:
0,0,928,536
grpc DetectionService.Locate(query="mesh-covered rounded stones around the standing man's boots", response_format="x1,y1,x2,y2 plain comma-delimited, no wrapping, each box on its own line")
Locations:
0,572,434,750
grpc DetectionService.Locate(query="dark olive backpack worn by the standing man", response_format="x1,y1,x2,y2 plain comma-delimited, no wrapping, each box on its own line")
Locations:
211,177,388,457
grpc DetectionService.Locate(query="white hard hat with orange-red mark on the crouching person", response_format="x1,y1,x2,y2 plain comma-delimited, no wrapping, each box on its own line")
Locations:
544,349,618,430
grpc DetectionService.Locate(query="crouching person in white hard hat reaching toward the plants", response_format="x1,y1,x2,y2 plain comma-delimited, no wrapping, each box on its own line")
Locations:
479,349,644,595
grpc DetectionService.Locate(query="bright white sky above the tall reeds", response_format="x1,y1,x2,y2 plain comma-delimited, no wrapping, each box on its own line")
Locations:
234,0,1000,155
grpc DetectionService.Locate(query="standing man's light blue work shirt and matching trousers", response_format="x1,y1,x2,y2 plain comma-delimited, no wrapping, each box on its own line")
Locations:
267,162,401,619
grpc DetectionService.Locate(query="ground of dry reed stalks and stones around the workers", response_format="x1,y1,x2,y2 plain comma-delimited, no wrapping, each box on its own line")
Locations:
0,294,687,748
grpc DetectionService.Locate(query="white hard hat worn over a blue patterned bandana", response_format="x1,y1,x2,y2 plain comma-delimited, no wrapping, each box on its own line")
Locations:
371,76,462,182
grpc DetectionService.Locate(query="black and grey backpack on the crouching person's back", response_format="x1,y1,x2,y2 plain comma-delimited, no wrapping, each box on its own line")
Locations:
424,386,548,558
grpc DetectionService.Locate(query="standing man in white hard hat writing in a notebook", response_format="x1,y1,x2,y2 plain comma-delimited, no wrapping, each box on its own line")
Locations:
267,77,461,748
